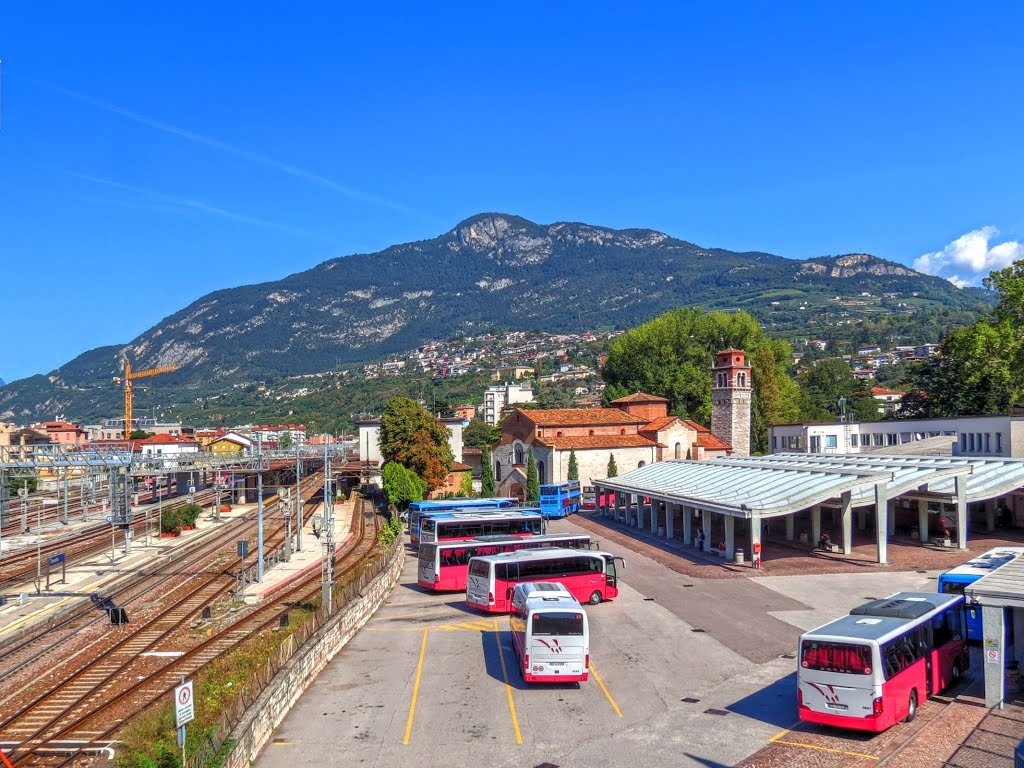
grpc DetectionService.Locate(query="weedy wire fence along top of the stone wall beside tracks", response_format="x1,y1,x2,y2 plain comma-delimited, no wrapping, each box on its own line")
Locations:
188,505,402,768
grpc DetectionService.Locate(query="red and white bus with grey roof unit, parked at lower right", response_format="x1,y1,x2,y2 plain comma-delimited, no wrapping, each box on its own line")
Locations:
797,592,970,733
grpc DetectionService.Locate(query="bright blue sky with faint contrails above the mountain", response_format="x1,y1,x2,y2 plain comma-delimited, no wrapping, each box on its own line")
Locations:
0,0,1024,381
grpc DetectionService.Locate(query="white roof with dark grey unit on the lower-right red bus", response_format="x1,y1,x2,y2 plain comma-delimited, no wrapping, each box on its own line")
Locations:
801,592,964,643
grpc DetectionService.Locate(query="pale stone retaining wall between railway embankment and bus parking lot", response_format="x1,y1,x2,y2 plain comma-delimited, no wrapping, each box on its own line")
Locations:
224,543,406,768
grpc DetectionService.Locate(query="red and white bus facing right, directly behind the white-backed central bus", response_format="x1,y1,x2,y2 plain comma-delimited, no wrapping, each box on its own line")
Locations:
466,548,623,613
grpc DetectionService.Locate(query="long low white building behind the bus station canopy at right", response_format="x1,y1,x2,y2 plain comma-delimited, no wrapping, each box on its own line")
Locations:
768,416,1024,459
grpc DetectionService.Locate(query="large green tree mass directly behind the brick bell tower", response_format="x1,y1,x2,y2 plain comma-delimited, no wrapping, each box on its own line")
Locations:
601,308,800,453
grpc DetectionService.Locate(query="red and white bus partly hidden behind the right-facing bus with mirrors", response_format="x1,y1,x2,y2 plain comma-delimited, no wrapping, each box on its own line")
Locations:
417,534,591,592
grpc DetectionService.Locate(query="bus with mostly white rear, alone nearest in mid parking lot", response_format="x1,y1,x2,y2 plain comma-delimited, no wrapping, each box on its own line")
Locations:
509,582,590,683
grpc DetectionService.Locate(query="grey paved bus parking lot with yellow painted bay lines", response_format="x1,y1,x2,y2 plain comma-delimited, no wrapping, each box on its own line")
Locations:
257,522,950,768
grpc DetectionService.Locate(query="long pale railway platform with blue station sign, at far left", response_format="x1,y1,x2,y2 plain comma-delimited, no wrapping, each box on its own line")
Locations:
0,505,255,644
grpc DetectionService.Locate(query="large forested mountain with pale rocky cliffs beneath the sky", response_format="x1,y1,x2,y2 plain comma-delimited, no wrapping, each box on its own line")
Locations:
0,213,986,421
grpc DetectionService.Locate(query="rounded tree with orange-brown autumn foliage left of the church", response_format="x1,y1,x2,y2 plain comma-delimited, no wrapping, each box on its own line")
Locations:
380,397,452,490
